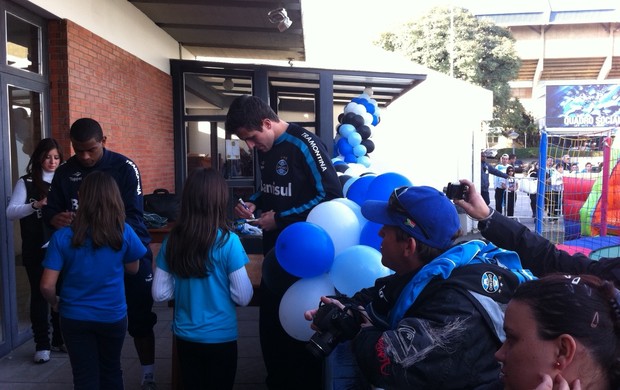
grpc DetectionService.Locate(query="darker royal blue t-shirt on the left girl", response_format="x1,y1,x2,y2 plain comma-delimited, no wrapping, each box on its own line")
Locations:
43,224,146,323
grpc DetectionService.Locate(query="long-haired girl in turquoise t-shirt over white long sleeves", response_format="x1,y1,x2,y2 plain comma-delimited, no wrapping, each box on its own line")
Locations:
153,168,253,390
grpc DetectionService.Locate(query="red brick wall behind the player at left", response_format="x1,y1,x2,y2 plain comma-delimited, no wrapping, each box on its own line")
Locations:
49,20,174,193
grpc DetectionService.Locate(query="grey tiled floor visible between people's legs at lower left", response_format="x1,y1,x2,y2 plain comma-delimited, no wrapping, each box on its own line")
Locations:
0,303,267,390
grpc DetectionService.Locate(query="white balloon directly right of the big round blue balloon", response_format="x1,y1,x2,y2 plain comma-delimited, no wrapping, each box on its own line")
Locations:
306,200,362,256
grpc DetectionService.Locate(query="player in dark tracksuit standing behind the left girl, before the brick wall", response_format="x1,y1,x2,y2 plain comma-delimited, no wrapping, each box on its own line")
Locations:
43,118,157,383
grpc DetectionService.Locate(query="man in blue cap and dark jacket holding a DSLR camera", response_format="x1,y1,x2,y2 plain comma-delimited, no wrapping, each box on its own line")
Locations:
305,186,533,389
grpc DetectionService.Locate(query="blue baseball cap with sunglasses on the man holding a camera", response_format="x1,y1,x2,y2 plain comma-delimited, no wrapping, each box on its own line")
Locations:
362,186,461,249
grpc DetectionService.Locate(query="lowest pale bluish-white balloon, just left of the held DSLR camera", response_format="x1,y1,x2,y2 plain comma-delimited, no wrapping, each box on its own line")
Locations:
279,274,336,341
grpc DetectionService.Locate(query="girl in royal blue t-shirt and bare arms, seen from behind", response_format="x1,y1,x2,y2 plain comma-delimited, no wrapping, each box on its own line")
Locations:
41,172,146,390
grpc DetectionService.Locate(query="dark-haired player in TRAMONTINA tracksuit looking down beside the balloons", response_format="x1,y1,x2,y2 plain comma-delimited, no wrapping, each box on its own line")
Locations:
226,96,343,390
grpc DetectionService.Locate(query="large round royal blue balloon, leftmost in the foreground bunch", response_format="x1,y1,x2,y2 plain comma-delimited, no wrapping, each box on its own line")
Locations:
275,222,335,278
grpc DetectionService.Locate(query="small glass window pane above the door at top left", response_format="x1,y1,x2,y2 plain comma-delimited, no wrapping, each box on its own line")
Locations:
6,12,41,74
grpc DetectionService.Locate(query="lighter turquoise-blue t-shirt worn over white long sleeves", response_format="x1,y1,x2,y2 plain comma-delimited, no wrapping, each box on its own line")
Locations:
156,231,249,343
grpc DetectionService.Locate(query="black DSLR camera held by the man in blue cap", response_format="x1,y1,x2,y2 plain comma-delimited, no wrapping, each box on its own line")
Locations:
306,297,362,358
